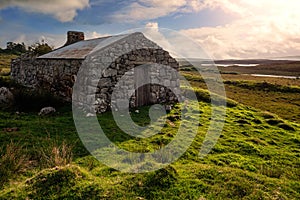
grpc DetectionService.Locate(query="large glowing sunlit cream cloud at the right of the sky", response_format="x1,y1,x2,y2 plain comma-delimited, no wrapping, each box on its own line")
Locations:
181,0,300,58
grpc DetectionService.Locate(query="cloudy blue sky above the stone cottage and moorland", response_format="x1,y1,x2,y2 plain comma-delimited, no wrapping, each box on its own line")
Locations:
0,0,300,59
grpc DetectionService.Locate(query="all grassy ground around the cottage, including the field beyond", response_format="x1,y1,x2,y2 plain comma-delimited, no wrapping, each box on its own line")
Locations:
0,56,300,200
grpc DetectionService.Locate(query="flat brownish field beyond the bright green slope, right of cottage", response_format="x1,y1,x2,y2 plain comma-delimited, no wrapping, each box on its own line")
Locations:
182,72,300,122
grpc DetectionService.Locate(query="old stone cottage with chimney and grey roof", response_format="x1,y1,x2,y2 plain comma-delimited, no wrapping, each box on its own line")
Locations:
11,31,180,113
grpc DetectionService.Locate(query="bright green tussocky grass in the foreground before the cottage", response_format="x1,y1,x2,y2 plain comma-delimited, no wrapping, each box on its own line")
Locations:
0,99,300,199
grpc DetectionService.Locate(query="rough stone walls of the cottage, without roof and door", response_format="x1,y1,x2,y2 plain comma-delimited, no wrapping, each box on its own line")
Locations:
11,33,180,113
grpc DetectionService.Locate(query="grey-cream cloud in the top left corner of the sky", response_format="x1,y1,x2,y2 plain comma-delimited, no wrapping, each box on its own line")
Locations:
0,0,89,22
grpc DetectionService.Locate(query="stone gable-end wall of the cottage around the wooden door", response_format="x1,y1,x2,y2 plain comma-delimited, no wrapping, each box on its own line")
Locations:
73,34,180,113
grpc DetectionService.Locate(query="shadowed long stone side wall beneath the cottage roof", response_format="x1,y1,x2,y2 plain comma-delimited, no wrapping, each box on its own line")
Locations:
11,54,83,101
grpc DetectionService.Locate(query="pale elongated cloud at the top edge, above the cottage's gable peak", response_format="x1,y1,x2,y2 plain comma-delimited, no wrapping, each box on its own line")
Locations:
111,0,204,22
